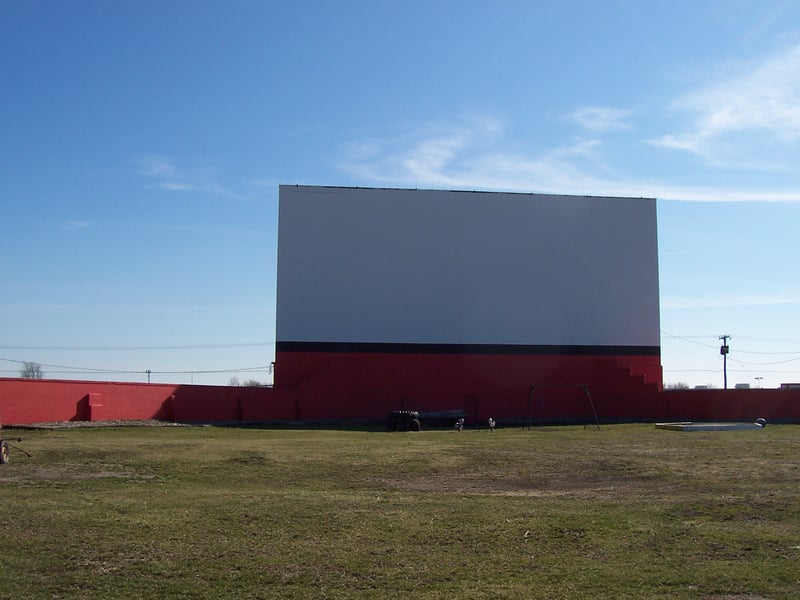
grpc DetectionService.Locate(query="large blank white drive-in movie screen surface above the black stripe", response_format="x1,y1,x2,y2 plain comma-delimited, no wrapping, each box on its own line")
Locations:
277,186,659,346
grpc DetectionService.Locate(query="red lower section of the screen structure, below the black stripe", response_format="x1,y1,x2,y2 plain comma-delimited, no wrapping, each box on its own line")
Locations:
276,352,661,421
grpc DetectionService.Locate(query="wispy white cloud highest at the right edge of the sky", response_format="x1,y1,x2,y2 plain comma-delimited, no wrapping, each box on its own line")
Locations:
651,45,800,163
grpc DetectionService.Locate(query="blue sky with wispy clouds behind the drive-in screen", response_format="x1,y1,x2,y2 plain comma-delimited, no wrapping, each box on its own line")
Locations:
0,0,800,387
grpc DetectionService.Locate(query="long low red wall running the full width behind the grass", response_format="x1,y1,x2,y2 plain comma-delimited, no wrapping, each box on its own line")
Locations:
0,378,800,424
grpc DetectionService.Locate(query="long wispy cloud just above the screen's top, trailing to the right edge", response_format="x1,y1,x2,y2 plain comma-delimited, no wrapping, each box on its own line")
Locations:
340,117,800,202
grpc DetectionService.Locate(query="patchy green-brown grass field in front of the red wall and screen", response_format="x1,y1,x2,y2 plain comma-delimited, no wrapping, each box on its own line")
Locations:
0,425,800,600
